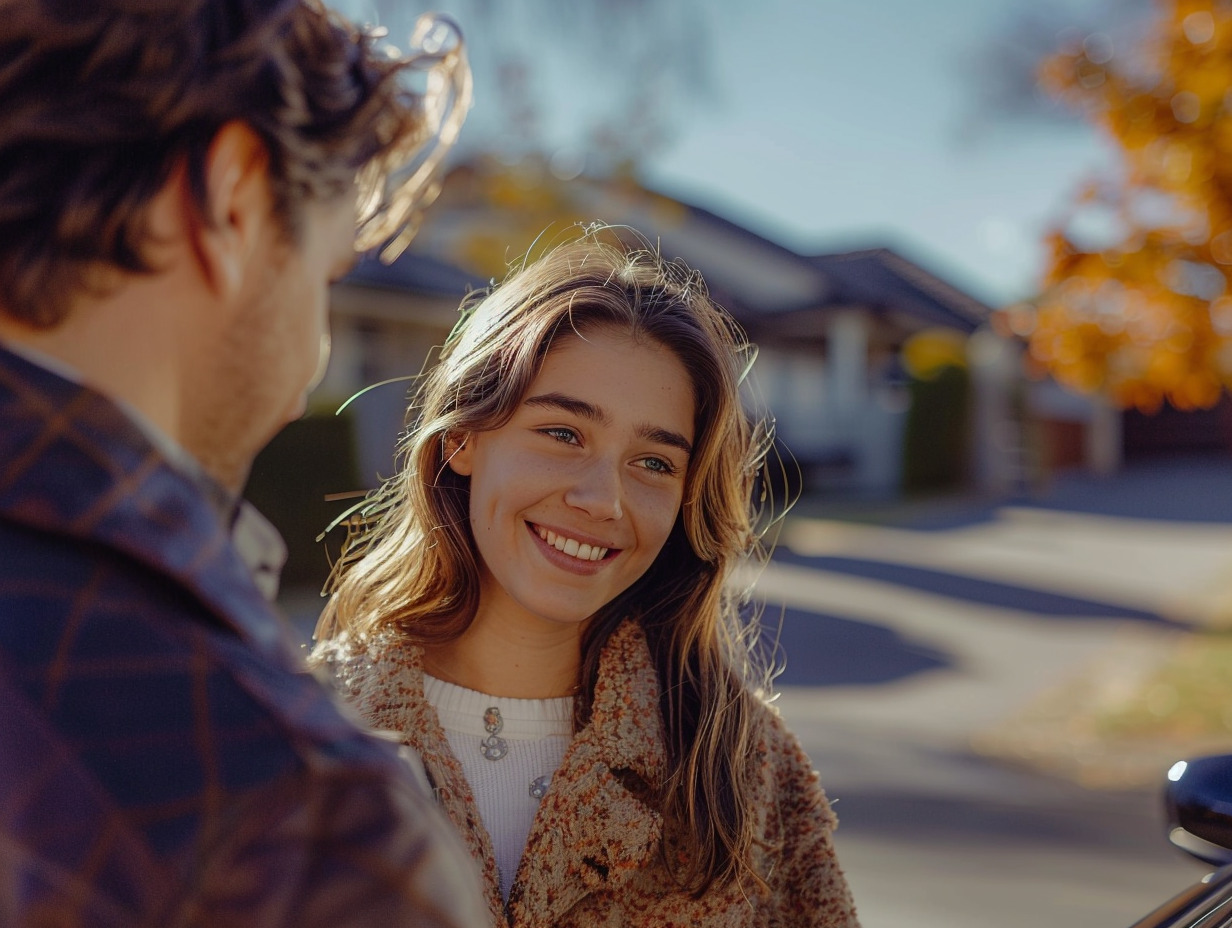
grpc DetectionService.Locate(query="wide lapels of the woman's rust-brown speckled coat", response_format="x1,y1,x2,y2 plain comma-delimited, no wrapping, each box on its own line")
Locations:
349,620,668,928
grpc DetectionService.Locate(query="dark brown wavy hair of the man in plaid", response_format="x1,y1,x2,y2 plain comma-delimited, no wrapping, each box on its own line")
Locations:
0,0,423,328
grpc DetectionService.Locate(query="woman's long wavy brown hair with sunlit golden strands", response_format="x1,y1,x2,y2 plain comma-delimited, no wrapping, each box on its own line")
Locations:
317,229,770,895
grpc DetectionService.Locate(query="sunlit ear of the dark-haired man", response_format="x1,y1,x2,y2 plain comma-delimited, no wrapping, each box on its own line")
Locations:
193,122,275,298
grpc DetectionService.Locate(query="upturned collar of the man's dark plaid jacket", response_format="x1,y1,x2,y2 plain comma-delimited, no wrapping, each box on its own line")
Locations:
0,348,293,663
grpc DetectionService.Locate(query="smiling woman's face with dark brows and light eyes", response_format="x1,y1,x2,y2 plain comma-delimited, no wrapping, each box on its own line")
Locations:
450,329,695,631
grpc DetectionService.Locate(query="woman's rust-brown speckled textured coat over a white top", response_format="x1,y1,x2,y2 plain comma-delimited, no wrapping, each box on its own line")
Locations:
319,621,857,928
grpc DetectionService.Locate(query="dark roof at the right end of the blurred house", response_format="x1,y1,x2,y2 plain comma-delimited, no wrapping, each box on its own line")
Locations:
809,248,992,333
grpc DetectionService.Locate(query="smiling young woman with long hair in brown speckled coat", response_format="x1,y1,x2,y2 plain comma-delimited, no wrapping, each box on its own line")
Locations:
315,233,856,928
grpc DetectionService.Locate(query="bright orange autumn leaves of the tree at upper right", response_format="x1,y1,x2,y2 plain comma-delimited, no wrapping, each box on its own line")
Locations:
1025,0,1232,412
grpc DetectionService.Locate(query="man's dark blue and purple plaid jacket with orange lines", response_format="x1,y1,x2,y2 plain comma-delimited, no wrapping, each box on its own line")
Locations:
0,349,485,928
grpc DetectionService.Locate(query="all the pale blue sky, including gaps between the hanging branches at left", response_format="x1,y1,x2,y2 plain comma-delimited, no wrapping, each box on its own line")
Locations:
339,0,1115,303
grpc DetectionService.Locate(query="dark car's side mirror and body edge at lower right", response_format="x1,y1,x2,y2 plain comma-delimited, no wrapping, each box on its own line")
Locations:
1132,754,1232,928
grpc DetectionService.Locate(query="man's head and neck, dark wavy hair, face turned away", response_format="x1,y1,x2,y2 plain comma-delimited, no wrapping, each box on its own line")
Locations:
0,0,464,482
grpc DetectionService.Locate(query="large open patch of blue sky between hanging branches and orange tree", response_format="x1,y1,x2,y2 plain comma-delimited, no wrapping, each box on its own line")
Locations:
647,0,1109,302
